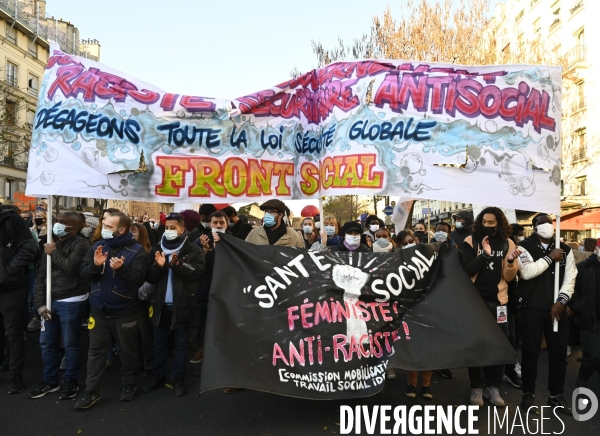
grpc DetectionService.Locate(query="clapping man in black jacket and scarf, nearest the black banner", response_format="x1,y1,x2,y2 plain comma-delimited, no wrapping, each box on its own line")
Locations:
142,213,205,397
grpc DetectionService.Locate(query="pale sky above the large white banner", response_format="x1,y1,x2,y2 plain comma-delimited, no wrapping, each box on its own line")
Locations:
46,0,502,214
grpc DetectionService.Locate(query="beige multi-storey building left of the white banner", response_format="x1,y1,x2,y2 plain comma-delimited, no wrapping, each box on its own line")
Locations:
0,0,100,210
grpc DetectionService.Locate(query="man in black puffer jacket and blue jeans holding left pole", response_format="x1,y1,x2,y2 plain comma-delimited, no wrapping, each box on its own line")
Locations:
29,212,90,400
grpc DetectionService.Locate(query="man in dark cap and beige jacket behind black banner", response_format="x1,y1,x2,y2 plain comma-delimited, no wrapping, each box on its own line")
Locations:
246,200,304,248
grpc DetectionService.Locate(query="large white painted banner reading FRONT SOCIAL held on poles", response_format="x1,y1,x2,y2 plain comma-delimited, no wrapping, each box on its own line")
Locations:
27,45,561,213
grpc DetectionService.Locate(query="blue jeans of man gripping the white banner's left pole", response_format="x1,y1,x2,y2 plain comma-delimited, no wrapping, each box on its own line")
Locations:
40,301,85,384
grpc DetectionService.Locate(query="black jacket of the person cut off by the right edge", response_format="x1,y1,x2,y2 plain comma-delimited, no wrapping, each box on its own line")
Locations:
569,253,600,330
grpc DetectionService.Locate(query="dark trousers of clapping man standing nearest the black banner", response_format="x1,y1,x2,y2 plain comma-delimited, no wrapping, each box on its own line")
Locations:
154,304,190,378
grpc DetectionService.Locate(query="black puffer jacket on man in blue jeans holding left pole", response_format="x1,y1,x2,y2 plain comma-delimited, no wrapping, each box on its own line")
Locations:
35,235,90,307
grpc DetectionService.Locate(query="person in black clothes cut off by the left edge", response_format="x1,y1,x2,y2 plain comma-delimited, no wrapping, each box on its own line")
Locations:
0,203,38,394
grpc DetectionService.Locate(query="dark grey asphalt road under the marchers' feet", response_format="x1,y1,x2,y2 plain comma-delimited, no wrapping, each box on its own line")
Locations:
0,332,600,436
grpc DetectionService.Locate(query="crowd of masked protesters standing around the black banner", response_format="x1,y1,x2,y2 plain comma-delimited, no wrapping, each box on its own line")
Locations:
0,199,600,414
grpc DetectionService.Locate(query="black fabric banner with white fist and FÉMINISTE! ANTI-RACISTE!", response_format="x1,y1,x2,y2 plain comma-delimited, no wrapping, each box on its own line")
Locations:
200,236,515,399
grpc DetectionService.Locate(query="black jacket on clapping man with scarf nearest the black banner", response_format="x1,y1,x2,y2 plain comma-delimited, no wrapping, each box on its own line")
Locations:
146,240,206,328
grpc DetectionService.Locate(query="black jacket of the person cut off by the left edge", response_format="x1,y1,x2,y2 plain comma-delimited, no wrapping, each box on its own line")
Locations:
0,209,38,292
